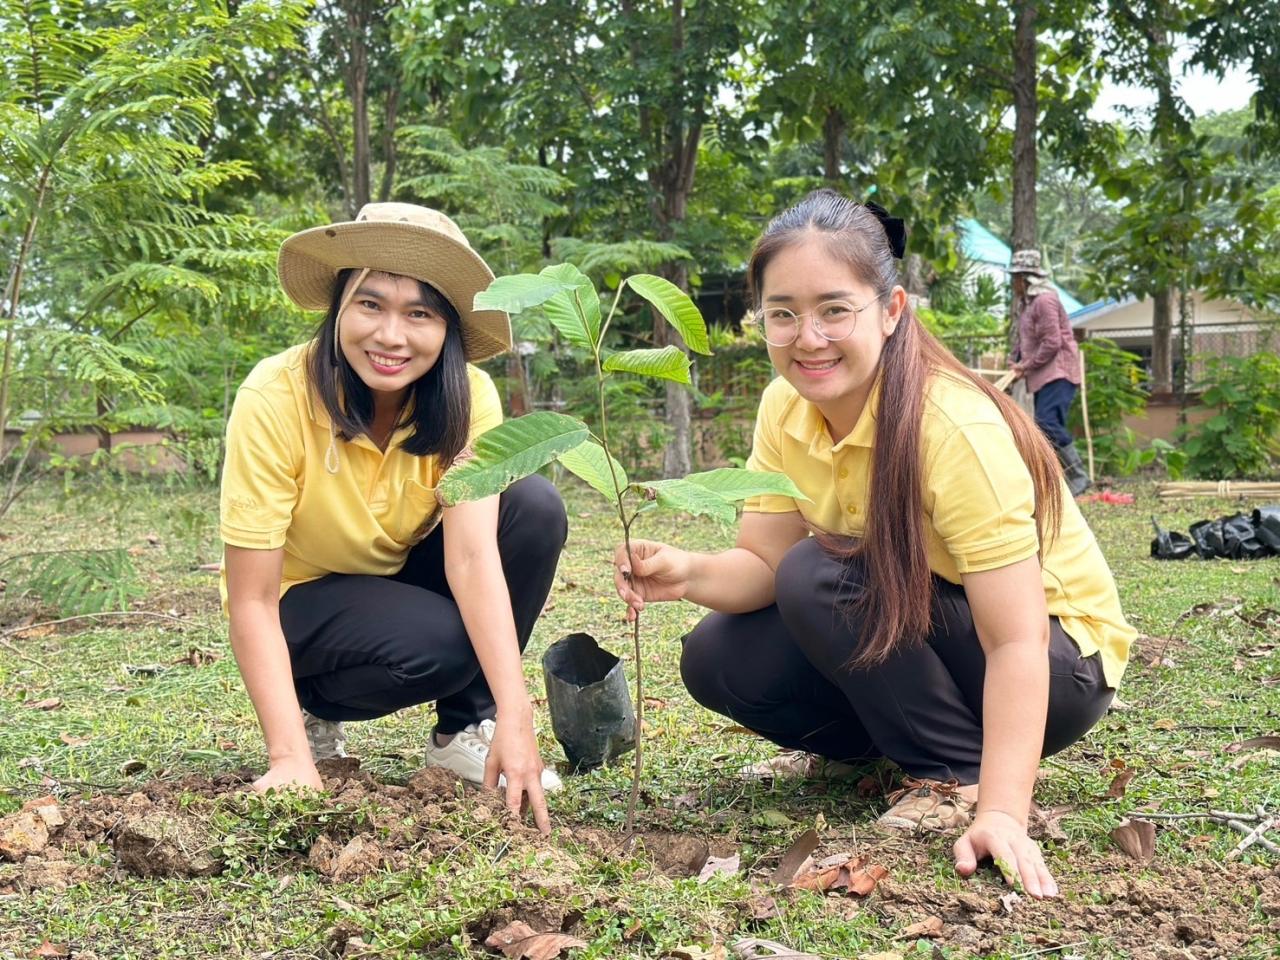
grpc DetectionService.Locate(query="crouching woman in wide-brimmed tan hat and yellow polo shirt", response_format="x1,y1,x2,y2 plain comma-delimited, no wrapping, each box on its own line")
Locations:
221,204,566,831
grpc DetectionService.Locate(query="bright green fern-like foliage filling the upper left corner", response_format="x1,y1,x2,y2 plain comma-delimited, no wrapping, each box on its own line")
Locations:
0,0,308,513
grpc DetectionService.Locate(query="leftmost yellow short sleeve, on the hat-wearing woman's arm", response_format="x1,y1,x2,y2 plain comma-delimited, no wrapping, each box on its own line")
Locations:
219,387,301,550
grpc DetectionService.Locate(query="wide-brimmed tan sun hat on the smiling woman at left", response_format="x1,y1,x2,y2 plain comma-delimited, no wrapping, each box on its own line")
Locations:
276,204,511,361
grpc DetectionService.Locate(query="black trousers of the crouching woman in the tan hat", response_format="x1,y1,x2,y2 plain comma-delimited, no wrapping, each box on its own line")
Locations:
280,476,568,733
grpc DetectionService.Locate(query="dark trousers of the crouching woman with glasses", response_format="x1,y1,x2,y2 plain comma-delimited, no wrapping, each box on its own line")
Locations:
680,539,1114,783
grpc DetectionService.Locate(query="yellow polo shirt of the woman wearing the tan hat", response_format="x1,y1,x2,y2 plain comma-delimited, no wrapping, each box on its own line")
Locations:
220,343,502,605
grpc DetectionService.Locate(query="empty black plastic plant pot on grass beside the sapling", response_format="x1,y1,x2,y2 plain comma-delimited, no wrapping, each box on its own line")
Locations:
543,634,636,772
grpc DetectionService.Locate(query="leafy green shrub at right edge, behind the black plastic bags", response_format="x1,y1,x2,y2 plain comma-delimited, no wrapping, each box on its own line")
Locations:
1183,352,1280,480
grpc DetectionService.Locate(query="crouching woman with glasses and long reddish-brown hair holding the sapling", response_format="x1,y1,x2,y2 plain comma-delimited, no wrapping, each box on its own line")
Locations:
614,191,1135,896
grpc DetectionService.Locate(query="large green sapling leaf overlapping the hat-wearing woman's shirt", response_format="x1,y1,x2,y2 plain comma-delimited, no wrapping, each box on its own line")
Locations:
436,412,588,507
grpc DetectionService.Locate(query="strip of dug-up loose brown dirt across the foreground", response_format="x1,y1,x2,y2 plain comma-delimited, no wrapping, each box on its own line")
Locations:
0,760,1280,960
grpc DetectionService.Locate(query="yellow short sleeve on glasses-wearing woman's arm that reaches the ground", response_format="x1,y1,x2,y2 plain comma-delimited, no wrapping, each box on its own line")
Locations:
924,424,1039,573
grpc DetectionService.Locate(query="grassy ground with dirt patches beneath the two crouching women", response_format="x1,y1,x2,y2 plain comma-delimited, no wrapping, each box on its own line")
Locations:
0,476,1280,960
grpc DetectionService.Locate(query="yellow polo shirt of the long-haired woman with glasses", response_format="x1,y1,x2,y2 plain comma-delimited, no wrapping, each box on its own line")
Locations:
746,374,1138,687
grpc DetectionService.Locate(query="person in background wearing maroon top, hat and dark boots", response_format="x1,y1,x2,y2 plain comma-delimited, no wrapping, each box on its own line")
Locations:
1009,250,1093,497
